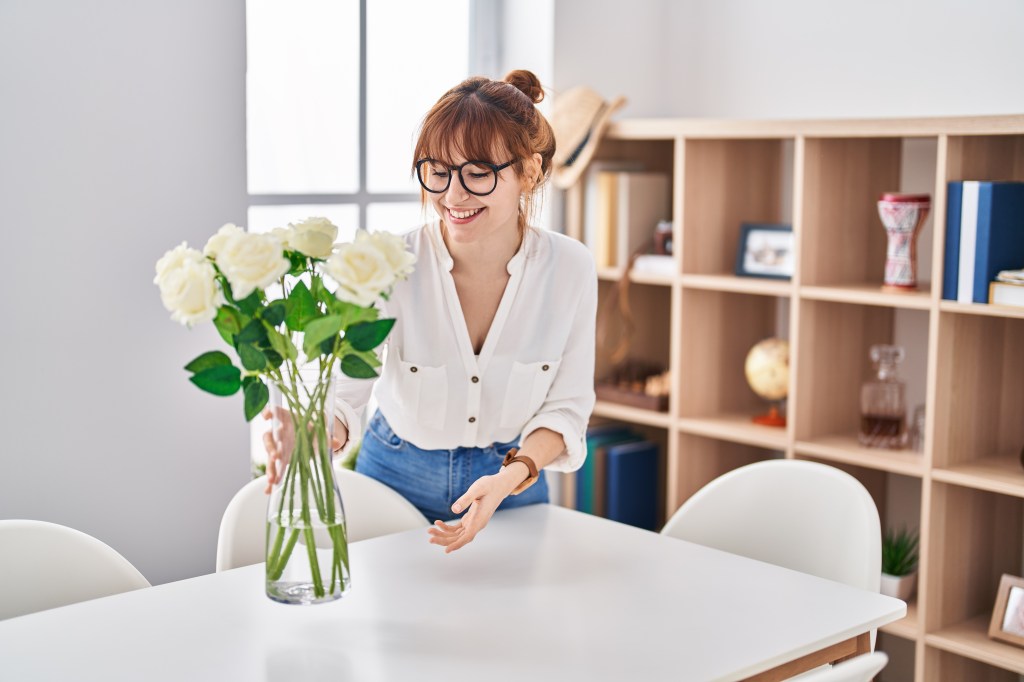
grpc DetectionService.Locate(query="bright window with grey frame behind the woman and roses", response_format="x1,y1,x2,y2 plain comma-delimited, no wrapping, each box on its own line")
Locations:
246,0,480,240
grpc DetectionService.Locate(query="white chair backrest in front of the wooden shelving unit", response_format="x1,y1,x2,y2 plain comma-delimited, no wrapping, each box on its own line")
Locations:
662,460,882,592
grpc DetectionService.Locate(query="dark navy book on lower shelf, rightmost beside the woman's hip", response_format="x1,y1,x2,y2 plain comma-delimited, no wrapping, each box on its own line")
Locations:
607,440,657,530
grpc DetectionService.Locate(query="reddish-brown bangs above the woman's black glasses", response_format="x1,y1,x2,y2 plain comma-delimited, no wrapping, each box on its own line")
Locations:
413,97,522,170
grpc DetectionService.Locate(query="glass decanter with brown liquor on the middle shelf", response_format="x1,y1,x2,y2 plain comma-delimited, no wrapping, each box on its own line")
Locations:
858,345,907,450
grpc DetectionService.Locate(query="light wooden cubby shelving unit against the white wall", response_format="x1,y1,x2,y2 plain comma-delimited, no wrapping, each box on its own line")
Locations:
565,116,1024,682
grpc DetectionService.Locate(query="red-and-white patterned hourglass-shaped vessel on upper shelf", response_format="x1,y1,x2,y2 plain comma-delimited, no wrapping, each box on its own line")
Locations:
879,193,932,292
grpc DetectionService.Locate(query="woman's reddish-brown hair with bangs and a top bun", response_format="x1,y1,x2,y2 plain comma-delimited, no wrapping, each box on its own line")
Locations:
413,70,555,231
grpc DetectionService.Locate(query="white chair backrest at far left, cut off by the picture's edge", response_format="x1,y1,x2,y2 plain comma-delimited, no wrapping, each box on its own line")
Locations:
0,519,150,619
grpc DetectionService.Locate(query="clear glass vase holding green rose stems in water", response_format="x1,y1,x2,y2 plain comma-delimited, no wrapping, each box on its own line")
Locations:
266,366,351,604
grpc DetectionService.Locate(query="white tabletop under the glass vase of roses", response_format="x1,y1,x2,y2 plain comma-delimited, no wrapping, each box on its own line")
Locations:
0,505,906,682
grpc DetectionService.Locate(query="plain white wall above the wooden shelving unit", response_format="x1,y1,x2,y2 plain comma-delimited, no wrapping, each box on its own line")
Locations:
555,0,1024,118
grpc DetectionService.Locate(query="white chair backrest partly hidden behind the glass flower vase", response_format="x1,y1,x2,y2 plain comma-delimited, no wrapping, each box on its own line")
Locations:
217,466,430,571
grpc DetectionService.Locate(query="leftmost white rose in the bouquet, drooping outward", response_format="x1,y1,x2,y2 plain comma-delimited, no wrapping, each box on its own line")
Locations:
153,242,224,327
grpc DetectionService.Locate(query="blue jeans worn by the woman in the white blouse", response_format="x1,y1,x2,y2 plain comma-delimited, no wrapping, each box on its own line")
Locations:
355,410,548,522
